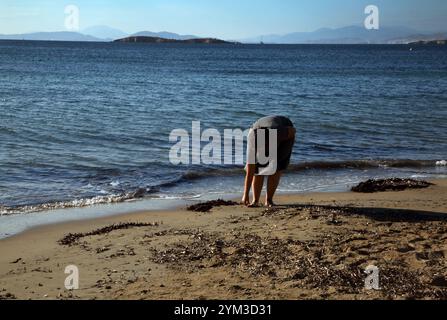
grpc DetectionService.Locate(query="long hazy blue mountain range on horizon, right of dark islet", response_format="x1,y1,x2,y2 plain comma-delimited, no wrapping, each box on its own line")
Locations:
241,26,438,44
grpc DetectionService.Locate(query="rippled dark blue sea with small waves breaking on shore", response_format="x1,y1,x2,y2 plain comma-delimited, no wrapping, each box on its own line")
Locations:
0,41,447,233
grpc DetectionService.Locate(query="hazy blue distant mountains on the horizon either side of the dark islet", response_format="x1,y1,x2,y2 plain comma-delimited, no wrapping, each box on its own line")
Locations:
0,26,447,44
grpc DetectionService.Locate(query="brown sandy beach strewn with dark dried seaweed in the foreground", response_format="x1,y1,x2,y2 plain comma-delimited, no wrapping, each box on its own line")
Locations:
0,180,447,300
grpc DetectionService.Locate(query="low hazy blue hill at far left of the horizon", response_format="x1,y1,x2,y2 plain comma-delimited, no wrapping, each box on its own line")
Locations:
0,31,105,42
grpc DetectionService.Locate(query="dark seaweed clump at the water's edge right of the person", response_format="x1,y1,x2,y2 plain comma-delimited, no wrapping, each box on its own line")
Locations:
351,178,433,193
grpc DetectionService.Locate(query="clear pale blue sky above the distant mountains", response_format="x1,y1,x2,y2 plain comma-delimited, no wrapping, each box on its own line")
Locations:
0,0,447,39
